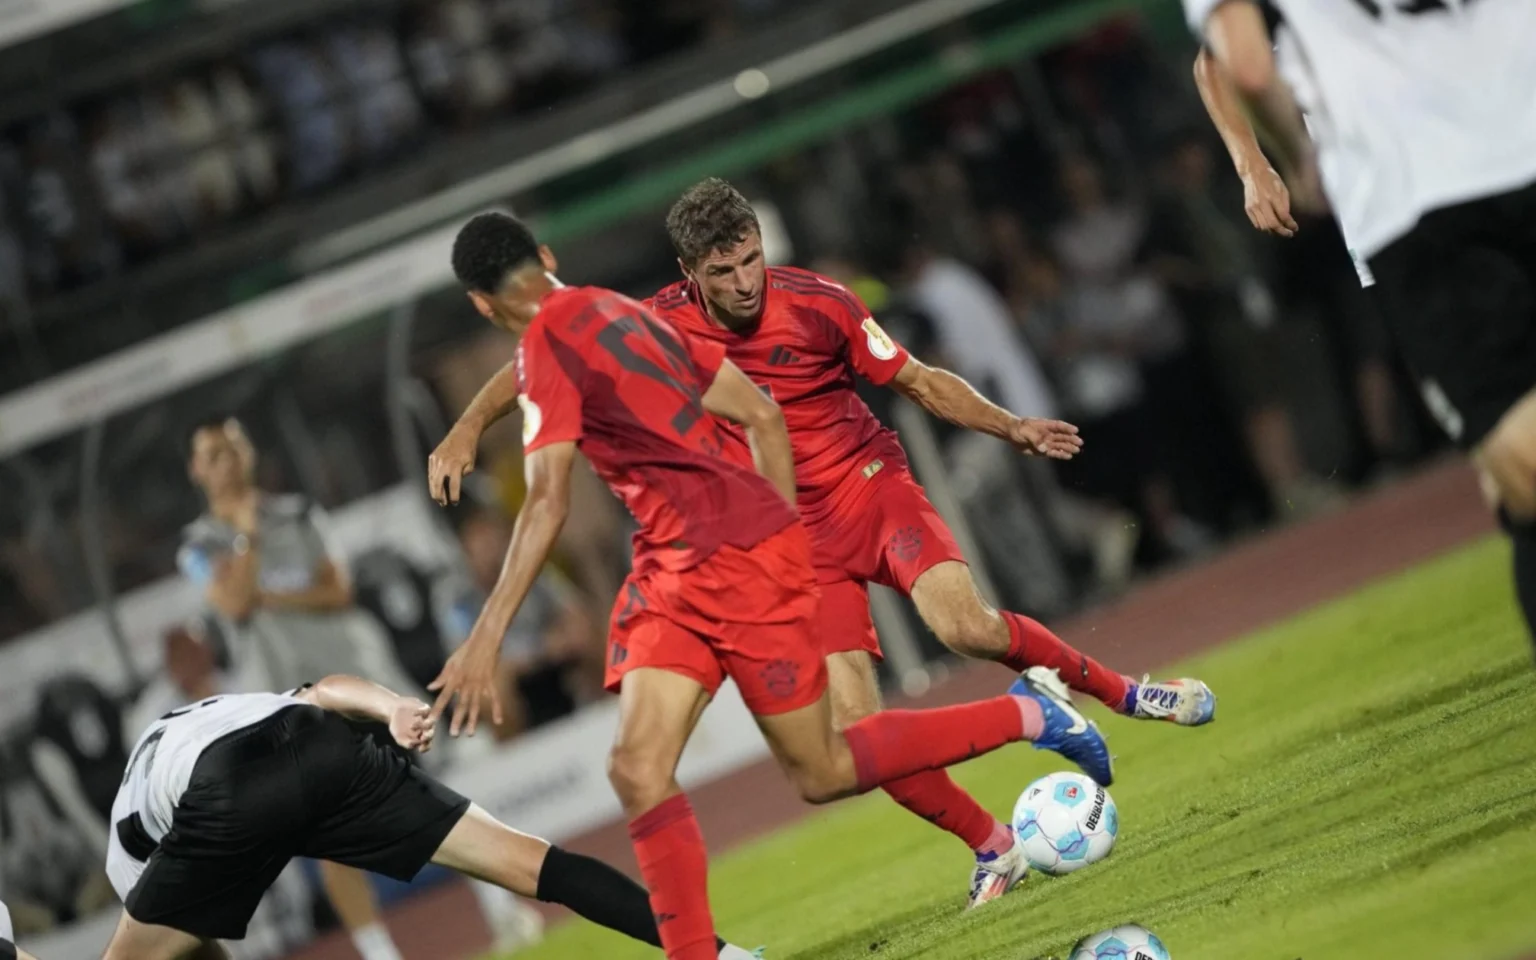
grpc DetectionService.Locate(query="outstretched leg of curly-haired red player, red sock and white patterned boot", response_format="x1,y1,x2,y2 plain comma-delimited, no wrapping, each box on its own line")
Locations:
911,561,1217,727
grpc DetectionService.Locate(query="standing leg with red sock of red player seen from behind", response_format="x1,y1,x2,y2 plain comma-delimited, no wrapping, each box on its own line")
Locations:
608,667,716,960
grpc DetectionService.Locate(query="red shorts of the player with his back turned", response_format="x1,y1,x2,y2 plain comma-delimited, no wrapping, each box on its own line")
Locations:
604,524,826,716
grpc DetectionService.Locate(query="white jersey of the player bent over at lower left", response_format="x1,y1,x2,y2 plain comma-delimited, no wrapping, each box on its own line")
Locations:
106,690,303,900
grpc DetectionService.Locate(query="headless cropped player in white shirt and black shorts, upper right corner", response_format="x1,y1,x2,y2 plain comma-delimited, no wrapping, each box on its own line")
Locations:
1184,0,1536,645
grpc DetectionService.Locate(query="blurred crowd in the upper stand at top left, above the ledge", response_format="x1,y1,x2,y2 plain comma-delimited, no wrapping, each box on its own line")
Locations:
0,0,791,300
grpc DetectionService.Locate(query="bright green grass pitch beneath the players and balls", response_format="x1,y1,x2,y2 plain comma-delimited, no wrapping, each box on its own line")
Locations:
518,542,1536,960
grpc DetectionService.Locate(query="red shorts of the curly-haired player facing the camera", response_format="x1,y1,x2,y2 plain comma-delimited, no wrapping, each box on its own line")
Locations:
808,472,965,660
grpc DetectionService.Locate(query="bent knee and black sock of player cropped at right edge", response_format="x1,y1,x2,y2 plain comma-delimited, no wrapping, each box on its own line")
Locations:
1473,390,1536,639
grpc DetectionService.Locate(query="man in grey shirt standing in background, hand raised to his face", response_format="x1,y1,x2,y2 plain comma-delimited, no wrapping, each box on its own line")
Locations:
177,419,413,960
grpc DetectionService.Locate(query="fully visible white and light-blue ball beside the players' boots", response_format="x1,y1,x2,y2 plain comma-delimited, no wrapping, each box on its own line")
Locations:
1014,773,1120,877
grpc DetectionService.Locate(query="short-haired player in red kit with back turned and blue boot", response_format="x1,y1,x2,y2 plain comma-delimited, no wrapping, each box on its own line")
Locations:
432,214,1112,960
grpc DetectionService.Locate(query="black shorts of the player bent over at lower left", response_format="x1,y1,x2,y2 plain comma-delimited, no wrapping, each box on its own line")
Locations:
124,705,470,940
